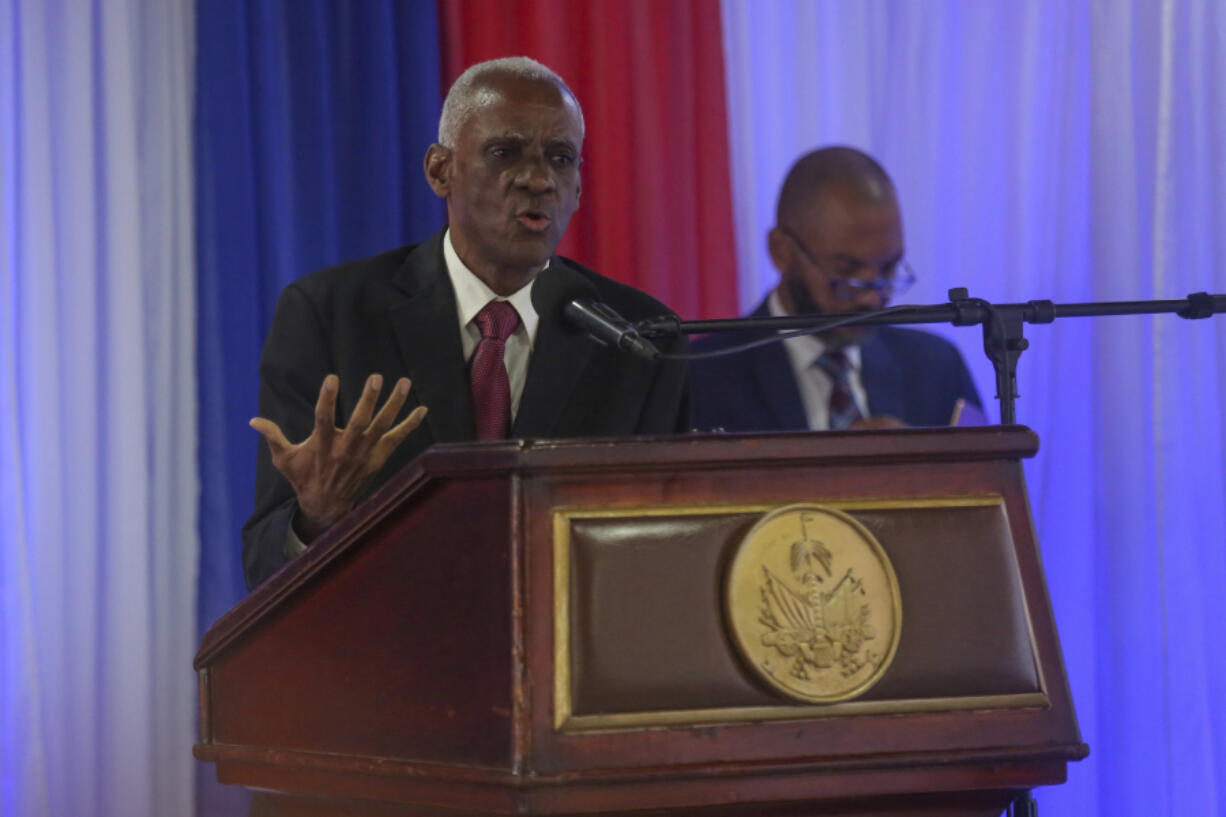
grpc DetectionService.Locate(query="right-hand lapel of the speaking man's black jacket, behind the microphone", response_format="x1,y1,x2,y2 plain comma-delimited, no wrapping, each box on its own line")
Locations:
511,264,596,437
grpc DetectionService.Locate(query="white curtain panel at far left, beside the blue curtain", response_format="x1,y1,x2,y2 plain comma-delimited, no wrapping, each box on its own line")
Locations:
0,0,199,817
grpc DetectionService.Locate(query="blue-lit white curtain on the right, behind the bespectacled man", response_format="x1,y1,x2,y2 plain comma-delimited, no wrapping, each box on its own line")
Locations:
723,0,1226,817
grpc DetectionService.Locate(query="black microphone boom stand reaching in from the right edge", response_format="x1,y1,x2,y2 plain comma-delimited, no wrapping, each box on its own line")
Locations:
635,287,1226,426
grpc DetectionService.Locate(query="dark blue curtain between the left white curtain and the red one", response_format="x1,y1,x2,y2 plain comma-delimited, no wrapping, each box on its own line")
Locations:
195,0,443,817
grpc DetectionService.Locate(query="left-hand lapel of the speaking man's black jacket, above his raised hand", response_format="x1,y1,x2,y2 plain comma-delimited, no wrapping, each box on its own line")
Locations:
390,231,474,443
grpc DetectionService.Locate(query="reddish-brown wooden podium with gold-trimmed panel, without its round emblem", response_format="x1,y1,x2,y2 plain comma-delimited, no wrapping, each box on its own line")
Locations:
195,426,1089,817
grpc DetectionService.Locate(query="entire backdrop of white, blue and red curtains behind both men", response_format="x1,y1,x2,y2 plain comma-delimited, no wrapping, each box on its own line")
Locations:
0,0,1226,817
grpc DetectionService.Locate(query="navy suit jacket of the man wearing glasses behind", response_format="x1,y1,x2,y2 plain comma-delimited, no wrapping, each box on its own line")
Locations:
690,295,981,432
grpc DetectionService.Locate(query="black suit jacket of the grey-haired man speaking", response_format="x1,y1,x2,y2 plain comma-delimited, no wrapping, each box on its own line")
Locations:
243,231,689,586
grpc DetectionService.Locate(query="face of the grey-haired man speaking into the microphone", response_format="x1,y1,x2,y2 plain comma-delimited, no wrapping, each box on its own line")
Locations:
425,75,582,289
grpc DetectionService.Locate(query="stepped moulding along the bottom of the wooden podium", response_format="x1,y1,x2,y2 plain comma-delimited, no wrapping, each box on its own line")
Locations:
188,743,1089,815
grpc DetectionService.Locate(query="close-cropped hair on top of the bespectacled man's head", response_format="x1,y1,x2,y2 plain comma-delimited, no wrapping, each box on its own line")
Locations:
775,147,895,224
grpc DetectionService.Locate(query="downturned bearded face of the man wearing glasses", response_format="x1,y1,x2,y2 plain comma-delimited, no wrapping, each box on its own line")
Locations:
769,185,902,345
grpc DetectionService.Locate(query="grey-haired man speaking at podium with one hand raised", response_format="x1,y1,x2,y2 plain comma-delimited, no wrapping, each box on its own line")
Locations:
243,58,689,588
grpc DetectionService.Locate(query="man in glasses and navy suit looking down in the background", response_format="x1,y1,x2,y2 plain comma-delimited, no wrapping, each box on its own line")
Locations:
690,147,981,431
